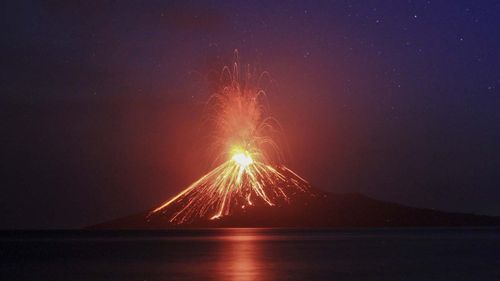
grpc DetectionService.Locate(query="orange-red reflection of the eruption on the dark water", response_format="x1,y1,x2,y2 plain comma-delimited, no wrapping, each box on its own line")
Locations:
215,229,273,281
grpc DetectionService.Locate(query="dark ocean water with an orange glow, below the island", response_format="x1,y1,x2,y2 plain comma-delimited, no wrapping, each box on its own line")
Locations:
0,228,500,281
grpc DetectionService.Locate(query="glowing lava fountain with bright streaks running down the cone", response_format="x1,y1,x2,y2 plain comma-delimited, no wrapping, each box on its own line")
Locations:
148,52,310,224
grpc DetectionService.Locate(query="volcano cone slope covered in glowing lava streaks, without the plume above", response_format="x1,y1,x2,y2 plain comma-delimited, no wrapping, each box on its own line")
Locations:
147,162,315,225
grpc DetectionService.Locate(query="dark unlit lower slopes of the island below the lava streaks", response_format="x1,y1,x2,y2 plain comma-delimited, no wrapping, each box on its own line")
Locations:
87,186,500,230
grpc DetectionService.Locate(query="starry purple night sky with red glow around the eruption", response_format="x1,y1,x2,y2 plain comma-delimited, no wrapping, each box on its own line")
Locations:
0,0,500,228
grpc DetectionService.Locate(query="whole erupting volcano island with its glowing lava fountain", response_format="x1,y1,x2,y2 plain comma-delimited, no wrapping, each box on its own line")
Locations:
90,51,498,229
